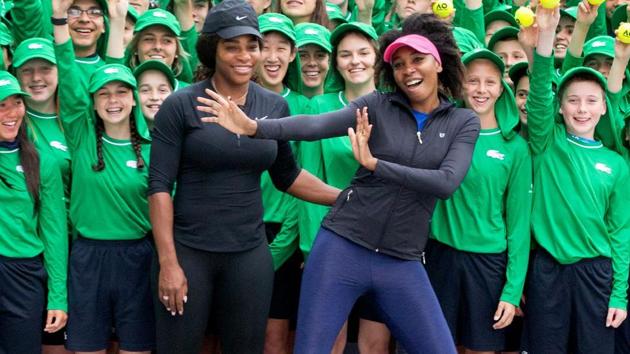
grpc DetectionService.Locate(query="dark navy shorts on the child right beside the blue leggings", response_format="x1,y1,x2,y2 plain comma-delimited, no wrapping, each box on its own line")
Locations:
426,240,507,351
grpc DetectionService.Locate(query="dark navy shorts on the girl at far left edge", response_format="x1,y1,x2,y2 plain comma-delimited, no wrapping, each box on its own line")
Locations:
0,256,46,354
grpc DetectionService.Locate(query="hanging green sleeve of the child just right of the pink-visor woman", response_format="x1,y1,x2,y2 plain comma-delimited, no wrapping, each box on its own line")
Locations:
501,143,532,307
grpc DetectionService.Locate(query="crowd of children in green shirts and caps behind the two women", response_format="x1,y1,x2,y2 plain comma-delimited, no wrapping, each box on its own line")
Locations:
0,0,630,353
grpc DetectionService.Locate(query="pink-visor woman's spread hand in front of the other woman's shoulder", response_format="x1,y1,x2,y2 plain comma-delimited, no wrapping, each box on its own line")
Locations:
197,89,258,135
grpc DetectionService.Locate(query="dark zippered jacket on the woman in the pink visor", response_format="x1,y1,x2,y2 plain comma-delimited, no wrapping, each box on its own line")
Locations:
256,92,480,260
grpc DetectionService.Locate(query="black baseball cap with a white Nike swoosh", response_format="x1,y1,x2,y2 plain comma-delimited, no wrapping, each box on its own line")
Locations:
201,0,262,39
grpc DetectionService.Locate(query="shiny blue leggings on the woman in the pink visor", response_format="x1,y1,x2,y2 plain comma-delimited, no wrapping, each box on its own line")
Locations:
295,228,456,354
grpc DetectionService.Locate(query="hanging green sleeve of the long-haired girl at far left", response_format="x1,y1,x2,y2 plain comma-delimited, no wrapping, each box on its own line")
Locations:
38,159,68,311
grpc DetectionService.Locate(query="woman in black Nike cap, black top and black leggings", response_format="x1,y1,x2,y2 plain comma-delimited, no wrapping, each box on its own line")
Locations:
149,0,339,354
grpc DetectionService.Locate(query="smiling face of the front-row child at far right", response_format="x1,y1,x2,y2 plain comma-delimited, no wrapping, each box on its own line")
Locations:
560,79,606,139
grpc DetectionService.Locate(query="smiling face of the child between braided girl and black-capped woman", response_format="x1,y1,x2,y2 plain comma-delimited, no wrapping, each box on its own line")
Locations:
138,70,173,120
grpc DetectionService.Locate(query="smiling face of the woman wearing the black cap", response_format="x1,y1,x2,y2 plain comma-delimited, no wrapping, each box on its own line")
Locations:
215,35,260,86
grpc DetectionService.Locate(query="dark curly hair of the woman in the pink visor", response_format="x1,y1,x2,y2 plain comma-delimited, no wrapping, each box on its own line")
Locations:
376,14,464,100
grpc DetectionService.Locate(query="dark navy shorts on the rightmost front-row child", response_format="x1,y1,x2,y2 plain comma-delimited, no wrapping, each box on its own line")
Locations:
524,248,615,354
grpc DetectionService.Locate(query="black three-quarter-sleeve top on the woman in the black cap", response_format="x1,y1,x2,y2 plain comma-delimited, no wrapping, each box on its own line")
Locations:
148,80,300,252
